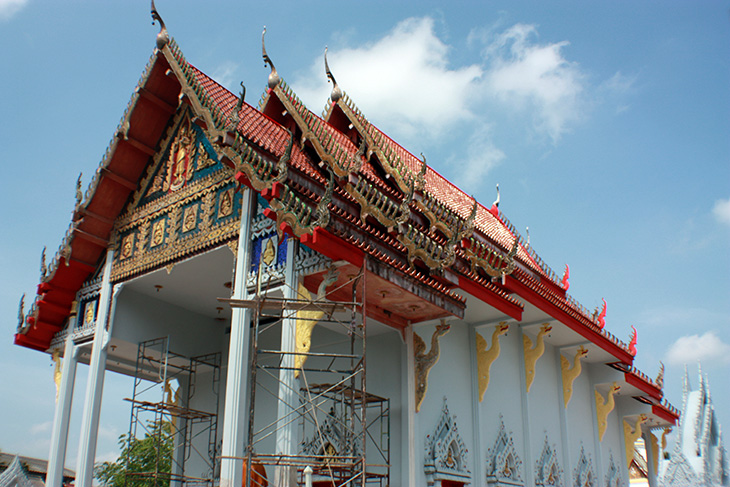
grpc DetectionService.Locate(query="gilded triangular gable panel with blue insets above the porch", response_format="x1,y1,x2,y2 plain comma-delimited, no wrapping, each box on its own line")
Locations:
112,109,241,281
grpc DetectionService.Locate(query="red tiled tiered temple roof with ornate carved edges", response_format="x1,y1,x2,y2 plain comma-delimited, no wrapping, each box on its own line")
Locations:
15,25,672,424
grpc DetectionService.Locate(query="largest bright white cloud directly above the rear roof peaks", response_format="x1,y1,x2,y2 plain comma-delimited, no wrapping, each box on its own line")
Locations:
293,18,482,142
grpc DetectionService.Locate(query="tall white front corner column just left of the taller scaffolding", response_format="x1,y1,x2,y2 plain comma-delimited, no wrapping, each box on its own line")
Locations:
220,189,256,487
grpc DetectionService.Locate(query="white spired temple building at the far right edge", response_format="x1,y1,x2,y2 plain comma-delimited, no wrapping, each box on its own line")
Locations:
659,367,730,487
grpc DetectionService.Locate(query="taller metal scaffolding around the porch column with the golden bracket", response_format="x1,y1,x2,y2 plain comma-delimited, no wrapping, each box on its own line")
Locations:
230,270,390,487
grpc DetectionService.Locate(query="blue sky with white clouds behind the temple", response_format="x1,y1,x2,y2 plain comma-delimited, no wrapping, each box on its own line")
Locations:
0,0,730,468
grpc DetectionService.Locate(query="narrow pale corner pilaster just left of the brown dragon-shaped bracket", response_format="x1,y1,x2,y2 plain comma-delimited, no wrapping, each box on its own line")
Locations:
401,325,412,487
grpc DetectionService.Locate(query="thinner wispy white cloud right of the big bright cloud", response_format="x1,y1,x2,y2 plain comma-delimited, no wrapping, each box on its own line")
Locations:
484,24,584,142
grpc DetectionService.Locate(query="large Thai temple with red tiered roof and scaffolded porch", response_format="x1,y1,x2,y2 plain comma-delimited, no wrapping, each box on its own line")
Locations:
15,4,684,487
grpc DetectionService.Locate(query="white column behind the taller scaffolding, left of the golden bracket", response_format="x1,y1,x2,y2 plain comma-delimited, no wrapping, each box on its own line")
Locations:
274,237,298,487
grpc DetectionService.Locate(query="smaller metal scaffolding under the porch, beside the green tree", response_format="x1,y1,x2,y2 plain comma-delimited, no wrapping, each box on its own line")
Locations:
125,337,221,486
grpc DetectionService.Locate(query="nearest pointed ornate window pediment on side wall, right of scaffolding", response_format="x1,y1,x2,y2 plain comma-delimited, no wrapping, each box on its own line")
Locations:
423,397,471,487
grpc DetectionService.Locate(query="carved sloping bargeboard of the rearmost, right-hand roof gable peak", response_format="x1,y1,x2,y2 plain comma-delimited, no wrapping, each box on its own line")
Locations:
337,94,416,194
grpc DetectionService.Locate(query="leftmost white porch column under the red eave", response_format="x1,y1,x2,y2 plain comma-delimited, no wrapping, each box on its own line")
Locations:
46,333,78,487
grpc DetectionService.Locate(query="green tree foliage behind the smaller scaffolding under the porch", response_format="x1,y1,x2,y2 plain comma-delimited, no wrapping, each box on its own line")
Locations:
94,421,173,487
